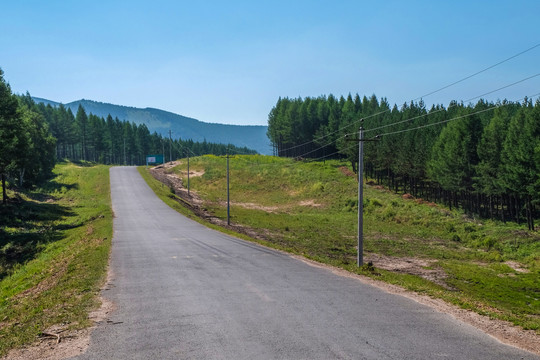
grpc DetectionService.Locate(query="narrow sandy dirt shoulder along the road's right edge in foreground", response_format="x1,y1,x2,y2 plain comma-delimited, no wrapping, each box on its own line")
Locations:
293,255,540,355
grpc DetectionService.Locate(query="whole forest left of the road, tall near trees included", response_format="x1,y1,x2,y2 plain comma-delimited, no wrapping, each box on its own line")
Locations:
0,69,256,203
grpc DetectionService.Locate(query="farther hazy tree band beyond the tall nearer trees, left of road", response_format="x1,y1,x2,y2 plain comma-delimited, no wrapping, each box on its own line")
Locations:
25,95,257,165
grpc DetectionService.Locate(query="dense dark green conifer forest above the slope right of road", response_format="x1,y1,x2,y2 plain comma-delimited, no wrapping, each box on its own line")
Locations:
268,95,540,229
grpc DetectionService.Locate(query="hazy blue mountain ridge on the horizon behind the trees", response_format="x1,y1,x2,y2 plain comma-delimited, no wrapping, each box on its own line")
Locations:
33,97,272,155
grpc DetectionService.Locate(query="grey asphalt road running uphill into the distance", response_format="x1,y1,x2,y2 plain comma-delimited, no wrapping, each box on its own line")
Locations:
74,167,539,360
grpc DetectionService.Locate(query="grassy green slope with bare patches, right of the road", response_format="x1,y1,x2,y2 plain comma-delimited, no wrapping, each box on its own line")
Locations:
141,156,540,333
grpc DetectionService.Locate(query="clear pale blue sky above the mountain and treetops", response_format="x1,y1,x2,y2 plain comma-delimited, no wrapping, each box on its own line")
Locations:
0,0,540,125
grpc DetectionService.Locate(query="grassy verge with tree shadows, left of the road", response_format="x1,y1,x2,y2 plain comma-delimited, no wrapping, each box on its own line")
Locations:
0,163,112,356
